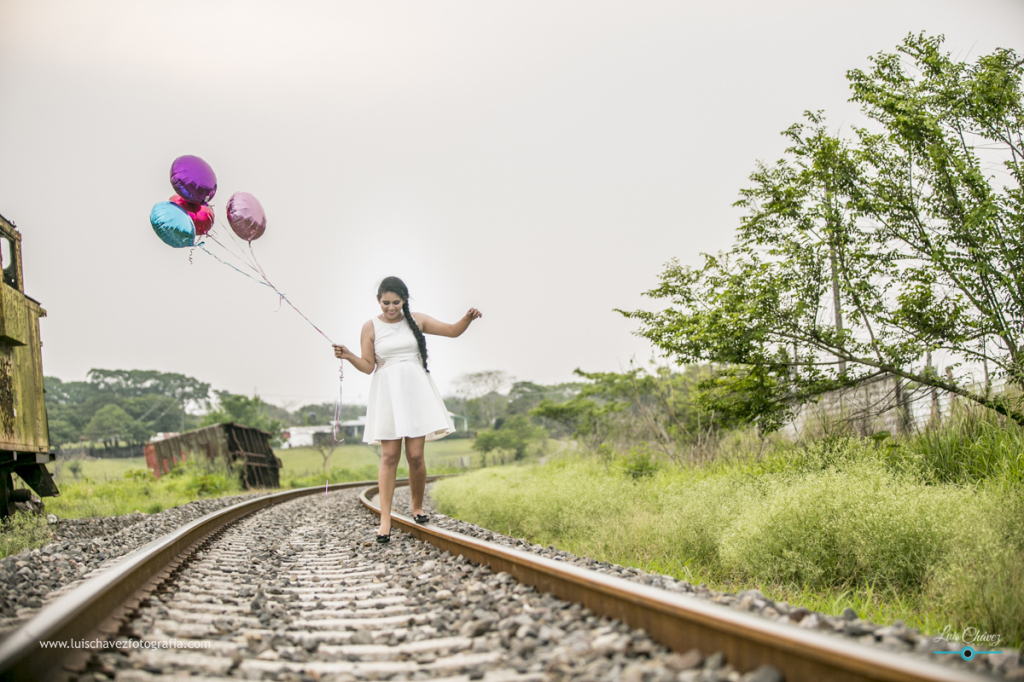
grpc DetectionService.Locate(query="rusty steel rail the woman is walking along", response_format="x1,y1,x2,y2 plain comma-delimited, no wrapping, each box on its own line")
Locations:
359,487,992,682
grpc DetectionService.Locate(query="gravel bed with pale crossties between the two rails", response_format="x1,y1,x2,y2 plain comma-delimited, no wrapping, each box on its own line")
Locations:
105,491,761,682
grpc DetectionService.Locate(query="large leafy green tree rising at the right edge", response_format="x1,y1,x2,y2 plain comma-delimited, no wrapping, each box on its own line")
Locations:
621,35,1024,431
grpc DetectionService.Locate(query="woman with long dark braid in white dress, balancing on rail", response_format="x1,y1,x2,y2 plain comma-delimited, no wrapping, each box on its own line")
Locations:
334,278,481,545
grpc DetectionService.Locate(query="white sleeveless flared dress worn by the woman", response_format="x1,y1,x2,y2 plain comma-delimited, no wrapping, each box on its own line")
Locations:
362,317,455,445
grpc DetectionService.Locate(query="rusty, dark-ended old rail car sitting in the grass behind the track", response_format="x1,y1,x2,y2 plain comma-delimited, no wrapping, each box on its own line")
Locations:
145,424,282,488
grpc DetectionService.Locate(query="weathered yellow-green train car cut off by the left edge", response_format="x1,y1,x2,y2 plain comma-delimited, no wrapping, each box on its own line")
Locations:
0,210,59,517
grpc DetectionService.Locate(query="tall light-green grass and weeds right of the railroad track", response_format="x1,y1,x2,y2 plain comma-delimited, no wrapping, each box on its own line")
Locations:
433,423,1024,645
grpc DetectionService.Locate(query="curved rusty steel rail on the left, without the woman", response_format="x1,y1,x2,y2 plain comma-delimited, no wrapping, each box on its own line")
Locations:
0,476,442,680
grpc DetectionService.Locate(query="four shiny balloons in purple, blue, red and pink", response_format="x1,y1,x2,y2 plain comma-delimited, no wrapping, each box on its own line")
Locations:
150,156,266,249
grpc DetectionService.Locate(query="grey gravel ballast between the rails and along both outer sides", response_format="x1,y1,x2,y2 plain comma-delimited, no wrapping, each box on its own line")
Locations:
0,481,1024,682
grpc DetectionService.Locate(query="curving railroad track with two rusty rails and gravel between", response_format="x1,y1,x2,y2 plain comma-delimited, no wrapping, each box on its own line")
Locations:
0,483,991,682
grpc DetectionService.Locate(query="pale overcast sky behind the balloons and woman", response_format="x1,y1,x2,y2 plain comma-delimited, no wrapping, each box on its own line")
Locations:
0,0,1024,408
